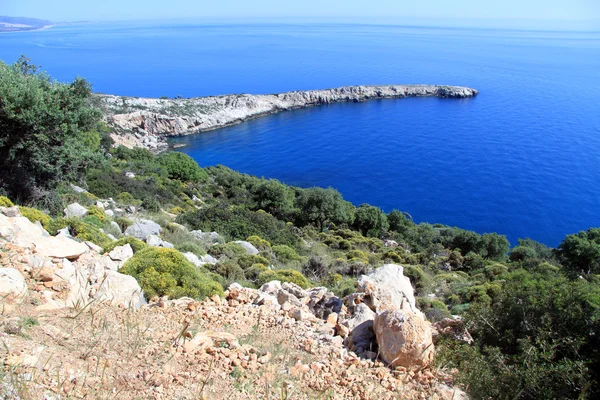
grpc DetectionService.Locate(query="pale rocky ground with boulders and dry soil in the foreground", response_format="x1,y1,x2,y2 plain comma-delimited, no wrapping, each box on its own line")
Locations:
0,207,466,399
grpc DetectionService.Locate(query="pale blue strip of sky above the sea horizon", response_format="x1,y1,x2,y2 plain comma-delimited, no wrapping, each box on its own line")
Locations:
0,0,600,28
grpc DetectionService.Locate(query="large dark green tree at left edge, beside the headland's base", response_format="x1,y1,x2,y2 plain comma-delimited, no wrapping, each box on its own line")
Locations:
0,57,104,201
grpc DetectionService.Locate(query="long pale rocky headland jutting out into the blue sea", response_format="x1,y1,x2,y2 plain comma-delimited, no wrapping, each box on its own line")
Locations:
94,85,478,150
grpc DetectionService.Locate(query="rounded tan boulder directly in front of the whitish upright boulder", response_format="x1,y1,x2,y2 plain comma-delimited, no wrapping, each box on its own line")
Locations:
373,309,435,368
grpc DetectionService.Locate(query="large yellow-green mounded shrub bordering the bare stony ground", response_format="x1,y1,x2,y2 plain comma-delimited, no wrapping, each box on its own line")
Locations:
120,247,223,299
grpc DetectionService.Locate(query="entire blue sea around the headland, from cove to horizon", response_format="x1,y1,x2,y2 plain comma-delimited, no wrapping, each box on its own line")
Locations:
0,22,600,246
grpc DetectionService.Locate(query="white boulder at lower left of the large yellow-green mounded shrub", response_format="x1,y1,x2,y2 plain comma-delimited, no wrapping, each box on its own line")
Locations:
93,270,147,309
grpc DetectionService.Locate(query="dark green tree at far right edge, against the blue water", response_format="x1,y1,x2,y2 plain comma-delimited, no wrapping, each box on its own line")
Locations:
556,228,600,274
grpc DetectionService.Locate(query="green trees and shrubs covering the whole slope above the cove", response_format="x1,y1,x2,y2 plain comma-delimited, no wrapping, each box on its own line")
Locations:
0,59,600,399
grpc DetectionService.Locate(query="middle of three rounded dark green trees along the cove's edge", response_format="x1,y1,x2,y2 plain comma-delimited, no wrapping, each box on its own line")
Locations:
296,188,354,231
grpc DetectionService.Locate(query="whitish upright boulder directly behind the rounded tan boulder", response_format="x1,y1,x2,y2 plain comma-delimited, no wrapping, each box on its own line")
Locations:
356,264,420,313
